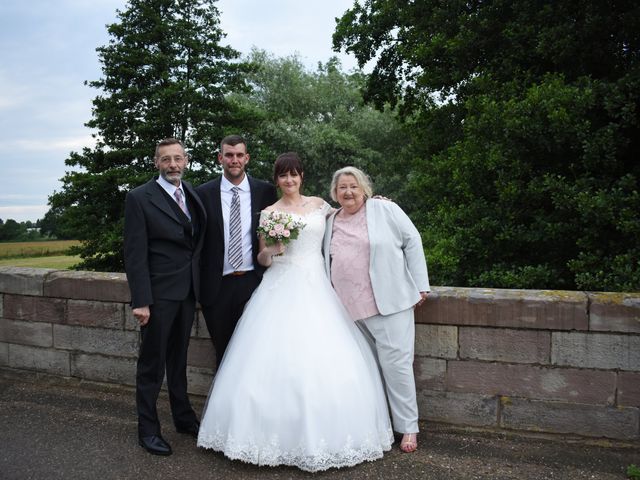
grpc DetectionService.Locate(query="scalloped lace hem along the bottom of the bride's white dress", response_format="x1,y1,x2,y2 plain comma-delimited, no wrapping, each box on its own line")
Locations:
198,429,393,472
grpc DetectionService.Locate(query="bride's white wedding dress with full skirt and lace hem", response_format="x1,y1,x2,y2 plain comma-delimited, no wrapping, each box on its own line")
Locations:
198,204,393,472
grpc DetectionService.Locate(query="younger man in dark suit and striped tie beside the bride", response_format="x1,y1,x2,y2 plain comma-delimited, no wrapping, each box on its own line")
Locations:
196,135,278,365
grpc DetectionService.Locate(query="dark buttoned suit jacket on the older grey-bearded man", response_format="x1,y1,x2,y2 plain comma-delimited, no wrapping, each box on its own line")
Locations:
124,178,207,308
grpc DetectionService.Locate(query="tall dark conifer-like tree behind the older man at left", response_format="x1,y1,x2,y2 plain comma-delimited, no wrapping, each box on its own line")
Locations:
49,0,247,271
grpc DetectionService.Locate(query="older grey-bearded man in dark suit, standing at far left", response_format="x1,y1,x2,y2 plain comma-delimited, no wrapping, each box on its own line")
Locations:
124,138,207,455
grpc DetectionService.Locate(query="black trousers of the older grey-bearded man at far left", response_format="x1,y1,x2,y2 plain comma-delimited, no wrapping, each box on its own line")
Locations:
136,294,197,436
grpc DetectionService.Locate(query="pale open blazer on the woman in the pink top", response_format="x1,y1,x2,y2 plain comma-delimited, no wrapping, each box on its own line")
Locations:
323,198,431,315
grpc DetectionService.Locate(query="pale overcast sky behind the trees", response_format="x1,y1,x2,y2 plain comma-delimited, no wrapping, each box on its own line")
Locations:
0,0,356,222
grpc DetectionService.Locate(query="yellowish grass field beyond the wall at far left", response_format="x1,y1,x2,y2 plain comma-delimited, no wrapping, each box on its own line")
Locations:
0,240,80,270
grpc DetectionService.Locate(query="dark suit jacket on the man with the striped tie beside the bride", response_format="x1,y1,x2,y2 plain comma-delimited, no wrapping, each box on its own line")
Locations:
196,175,278,306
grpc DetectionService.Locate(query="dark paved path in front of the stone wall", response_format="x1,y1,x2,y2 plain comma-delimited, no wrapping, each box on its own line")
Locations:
0,369,640,480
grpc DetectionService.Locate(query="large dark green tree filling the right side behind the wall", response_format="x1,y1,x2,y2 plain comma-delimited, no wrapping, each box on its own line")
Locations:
334,0,640,290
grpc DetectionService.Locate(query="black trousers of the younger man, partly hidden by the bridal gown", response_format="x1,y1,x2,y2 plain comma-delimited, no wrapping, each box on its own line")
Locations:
202,271,260,366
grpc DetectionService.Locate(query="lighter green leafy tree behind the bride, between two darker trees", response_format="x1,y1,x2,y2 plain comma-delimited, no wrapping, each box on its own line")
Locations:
230,50,406,200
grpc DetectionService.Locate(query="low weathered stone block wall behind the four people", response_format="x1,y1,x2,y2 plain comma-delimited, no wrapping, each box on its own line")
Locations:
0,267,640,441
